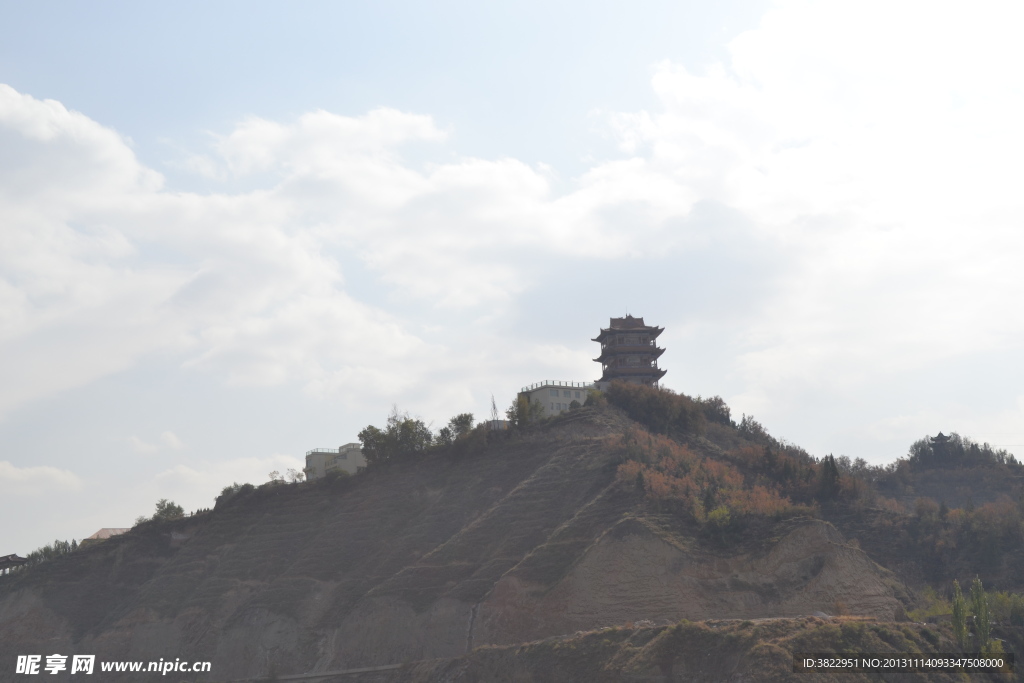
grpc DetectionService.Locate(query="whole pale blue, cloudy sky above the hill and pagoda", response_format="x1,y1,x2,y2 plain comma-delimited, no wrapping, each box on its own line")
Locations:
0,0,1024,554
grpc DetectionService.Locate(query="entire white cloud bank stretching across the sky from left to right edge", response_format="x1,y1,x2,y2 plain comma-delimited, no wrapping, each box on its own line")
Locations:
0,2,1024,464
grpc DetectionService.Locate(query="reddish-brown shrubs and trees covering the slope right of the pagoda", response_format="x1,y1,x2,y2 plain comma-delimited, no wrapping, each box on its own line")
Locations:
608,385,1024,591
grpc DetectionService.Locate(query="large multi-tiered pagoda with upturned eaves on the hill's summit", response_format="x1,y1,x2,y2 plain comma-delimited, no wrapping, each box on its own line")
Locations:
593,315,668,386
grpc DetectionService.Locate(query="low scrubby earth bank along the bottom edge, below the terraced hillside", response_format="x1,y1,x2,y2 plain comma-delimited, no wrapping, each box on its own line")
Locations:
391,616,999,683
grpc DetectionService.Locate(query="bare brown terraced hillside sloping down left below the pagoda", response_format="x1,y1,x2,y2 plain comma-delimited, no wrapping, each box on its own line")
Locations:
0,409,903,680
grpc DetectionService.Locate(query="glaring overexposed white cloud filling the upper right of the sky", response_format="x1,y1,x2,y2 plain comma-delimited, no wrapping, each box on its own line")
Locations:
611,2,1024,428
